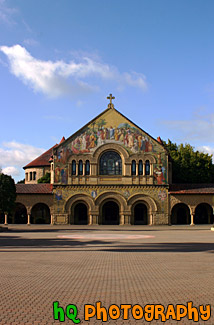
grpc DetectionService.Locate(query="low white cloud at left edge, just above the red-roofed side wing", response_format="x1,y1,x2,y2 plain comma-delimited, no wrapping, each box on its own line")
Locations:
0,141,45,178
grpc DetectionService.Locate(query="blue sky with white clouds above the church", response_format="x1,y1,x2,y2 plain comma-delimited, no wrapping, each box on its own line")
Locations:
0,0,214,180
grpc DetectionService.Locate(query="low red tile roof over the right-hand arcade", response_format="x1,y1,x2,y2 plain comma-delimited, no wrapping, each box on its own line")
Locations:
169,184,214,194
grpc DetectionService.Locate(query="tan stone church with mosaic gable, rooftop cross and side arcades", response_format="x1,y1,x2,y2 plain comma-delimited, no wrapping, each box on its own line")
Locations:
2,95,214,225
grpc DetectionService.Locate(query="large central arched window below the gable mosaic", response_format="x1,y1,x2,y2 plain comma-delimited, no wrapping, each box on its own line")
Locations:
100,151,122,175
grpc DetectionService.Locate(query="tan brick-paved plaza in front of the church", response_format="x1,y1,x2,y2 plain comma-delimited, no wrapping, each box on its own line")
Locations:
0,225,214,325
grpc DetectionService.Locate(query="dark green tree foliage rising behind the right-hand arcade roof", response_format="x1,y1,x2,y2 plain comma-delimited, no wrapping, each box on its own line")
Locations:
163,139,214,183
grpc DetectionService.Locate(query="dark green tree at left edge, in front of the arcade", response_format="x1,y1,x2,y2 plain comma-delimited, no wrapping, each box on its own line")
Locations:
0,173,16,213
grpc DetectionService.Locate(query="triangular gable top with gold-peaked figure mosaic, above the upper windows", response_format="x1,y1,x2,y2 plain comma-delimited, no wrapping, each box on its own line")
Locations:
56,108,165,160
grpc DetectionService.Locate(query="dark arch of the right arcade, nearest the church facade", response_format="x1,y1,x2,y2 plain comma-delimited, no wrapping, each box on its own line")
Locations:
171,203,190,225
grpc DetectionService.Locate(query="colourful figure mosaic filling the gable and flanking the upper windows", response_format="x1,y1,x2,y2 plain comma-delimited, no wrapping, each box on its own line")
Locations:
55,110,167,185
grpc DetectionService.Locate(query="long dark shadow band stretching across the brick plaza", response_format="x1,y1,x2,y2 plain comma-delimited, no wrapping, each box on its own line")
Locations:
0,235,214,253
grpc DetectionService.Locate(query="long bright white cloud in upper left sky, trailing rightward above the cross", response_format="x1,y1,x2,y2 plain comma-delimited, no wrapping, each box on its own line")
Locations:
0,45,147,97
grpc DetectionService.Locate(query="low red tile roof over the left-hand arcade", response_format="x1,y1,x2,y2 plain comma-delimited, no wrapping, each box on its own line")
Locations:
16,183,53,194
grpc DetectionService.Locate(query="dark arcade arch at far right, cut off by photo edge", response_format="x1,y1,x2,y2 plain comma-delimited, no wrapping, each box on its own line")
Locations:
194,203,213,225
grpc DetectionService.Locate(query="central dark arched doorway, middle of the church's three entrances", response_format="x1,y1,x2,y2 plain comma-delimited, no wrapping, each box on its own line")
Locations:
102,201,119,225
